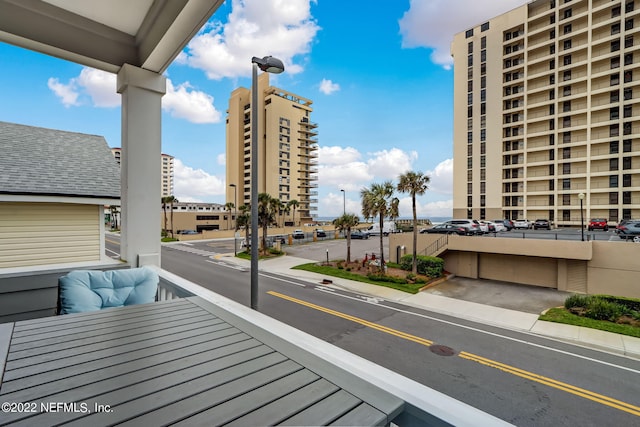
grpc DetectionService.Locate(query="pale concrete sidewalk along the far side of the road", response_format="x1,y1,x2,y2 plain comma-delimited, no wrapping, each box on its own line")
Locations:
216,254,640,360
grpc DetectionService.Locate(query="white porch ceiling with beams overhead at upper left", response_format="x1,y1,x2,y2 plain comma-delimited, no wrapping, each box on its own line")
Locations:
0,0,224,73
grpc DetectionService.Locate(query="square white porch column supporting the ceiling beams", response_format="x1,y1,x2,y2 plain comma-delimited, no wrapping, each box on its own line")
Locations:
118,64,166,267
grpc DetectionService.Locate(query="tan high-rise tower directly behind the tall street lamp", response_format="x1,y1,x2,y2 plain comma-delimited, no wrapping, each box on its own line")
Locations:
226,73,318,225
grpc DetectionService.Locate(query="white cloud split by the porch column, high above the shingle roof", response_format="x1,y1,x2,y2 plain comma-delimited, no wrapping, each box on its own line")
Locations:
48,67,222,123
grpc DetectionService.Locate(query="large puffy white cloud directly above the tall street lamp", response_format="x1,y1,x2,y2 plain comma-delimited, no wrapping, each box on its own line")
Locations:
178,0,320,80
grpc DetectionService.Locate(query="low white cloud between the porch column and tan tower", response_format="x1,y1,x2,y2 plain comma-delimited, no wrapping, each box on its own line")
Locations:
173,159,225,202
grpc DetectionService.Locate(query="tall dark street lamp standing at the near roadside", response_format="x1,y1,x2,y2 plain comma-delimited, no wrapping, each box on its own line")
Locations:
251,56,284,310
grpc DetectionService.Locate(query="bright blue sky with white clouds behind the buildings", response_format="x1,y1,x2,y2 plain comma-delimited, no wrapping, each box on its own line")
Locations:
0,0,525,217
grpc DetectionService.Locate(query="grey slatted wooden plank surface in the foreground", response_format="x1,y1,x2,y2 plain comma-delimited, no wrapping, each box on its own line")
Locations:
0,297,404,427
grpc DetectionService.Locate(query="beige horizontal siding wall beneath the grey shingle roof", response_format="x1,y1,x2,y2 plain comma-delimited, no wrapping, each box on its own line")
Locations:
0,203,103,268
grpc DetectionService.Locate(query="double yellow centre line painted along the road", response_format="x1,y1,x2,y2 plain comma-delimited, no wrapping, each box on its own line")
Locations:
267,291,640,416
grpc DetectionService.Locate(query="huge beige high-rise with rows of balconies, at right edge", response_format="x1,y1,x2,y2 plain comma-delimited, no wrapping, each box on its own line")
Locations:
451,0,640,226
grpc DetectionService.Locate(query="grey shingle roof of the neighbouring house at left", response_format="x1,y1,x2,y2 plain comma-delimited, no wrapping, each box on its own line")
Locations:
0,122,120,199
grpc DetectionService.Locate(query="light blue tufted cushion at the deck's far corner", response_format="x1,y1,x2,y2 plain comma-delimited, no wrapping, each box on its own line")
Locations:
58,267,158,314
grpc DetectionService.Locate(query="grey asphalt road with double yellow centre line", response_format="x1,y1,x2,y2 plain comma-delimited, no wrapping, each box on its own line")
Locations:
107,236,640,426
